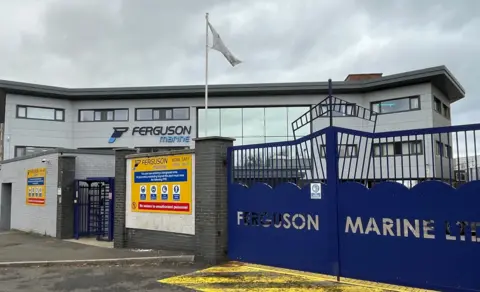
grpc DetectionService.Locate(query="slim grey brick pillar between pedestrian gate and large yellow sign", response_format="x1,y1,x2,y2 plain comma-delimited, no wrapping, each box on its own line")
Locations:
113,148,137,248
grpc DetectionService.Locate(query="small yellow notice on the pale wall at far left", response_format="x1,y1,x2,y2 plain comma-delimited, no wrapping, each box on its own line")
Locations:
26,167,47,206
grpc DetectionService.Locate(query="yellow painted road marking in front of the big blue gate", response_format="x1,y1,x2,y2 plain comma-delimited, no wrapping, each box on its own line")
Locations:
158,262,436,292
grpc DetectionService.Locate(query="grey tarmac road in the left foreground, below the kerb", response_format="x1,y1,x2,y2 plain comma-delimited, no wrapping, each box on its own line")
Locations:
0,263,202,292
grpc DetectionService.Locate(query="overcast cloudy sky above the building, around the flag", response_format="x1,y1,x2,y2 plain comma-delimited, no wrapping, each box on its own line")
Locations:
0,0,480,124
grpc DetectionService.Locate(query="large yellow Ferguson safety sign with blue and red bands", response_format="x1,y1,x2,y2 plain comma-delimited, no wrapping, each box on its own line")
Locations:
131,154,192,214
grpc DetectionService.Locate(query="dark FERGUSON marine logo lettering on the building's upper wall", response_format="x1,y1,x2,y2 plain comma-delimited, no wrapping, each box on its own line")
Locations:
108,126,192,144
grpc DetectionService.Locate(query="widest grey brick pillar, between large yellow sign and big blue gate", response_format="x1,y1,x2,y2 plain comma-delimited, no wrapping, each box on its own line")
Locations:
195,137,235,264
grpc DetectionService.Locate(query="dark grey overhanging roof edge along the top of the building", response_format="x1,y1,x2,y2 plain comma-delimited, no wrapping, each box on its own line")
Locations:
0,66,465,102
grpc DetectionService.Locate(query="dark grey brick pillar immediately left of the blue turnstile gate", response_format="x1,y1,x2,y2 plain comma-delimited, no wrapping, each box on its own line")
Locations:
56,155,76,239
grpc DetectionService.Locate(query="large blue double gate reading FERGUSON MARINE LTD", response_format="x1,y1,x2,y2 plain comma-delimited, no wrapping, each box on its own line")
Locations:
228,119,480,291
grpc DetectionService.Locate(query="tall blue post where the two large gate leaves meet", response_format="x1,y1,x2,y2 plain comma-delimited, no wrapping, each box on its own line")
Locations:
325,126,340,281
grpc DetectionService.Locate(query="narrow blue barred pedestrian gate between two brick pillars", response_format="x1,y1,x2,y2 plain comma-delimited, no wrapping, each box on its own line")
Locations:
74,177,115,241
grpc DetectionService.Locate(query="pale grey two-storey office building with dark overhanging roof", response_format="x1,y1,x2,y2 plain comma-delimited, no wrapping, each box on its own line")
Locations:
0,66,465,182
